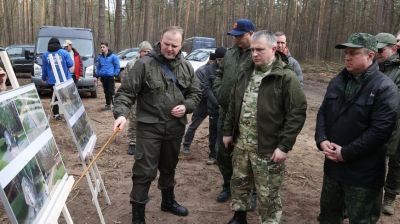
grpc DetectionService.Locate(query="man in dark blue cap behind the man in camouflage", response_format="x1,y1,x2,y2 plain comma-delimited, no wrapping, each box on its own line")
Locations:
213,19,255,202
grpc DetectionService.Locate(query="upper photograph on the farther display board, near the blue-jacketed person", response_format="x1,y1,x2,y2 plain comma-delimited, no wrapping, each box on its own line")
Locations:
56,81,83,118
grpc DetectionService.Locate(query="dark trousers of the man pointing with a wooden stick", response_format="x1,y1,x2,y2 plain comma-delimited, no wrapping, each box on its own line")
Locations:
130,119,185,204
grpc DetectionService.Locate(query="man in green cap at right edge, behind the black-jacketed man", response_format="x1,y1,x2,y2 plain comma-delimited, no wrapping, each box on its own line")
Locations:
375,33,400,215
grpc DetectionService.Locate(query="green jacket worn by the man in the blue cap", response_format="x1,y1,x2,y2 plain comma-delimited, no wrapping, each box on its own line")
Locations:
213,45,252,111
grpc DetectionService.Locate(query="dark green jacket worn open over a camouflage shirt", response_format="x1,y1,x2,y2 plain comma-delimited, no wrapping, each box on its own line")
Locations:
223,53,307,154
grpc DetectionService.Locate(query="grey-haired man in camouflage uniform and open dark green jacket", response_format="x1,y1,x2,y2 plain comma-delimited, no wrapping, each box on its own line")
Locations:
223,31,307,224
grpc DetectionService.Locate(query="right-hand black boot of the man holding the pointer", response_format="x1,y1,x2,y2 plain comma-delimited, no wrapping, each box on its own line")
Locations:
161,188,189,216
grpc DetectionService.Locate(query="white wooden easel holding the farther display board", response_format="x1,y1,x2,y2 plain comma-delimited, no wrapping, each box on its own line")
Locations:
49,54,111,224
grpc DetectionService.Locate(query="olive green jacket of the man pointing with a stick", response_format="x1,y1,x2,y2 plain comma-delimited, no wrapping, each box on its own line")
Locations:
113,44,202,124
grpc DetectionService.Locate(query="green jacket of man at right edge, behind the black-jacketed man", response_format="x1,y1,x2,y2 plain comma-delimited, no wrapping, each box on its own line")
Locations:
379,54,400,155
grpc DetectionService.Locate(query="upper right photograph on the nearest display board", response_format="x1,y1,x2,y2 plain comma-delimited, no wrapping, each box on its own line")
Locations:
14,90,49,142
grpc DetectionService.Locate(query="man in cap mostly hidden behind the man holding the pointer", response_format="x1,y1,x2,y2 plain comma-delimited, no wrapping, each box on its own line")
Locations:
126,41,153,155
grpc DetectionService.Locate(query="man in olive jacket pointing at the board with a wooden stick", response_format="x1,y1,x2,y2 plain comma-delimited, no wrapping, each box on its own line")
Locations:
113,26,202,224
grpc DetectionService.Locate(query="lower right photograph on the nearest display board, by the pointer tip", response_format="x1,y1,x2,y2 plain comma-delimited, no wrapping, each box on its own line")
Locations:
36,138,66,192
